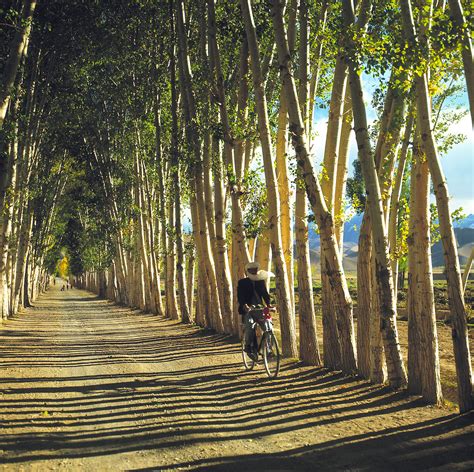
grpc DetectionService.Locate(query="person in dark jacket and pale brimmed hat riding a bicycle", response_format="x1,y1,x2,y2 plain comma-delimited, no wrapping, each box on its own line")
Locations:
237,262,274,360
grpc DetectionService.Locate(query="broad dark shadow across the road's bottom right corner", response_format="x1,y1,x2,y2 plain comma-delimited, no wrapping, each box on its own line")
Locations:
134,415,474,472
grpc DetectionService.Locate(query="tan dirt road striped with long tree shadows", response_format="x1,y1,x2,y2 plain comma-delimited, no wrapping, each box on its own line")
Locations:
0,285,474,472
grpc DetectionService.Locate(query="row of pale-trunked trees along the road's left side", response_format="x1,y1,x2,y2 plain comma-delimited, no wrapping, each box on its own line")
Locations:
0,1,62,318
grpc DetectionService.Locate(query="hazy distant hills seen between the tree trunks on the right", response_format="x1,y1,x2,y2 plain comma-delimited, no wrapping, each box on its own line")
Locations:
309,215,474,271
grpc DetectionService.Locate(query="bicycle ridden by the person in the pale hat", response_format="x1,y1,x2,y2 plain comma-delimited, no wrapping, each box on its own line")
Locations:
242,307,280,378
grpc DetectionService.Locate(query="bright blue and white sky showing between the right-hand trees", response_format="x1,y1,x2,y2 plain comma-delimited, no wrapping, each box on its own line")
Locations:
313,77,474,215
